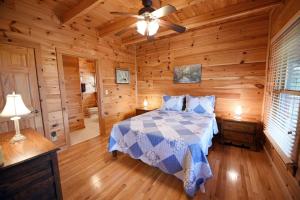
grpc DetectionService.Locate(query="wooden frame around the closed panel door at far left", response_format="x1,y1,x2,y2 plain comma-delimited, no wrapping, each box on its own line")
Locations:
0,38,50,139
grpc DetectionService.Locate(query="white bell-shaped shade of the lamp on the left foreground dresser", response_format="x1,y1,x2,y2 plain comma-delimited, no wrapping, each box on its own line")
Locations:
0,92,31,117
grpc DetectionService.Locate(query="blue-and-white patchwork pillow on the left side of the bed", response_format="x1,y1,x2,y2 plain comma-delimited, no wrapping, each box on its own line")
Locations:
161,95,185,111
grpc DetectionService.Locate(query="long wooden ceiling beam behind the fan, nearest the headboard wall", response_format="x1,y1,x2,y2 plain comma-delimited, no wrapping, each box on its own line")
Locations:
122,0,281,45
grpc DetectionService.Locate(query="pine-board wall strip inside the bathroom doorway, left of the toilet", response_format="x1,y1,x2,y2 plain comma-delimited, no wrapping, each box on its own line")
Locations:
62,55,85,132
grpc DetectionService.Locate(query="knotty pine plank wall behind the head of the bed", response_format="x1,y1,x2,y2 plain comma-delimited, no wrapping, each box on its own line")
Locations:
137,15,268,119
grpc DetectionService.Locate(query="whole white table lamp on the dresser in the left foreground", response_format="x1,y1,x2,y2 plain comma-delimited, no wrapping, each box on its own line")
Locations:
0,92,31,143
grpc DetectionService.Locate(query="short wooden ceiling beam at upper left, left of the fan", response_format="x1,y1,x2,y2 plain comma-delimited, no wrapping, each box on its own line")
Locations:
61,0,103,24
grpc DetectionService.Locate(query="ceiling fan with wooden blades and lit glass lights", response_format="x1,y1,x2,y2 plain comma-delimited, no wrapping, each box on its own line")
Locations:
111,0,186,40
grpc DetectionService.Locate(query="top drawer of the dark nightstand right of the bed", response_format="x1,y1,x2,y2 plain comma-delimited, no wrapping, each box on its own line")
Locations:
223,121,256,134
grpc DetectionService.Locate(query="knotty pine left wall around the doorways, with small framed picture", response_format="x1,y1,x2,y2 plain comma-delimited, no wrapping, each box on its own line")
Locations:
0,0,136,146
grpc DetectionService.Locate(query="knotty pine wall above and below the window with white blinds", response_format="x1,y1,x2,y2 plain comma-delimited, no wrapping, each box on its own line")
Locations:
265,0,300,199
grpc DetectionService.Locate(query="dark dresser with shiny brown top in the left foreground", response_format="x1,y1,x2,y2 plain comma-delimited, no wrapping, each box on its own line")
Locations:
0,129,62,200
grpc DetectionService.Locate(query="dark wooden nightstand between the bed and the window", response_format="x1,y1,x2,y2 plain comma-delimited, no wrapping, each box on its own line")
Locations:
221,117,262,151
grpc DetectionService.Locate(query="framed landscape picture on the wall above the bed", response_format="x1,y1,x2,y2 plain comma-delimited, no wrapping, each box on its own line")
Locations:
174,64,201,83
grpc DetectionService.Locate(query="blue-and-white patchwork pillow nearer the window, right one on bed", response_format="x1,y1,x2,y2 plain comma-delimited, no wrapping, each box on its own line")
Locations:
186,96,215,114
